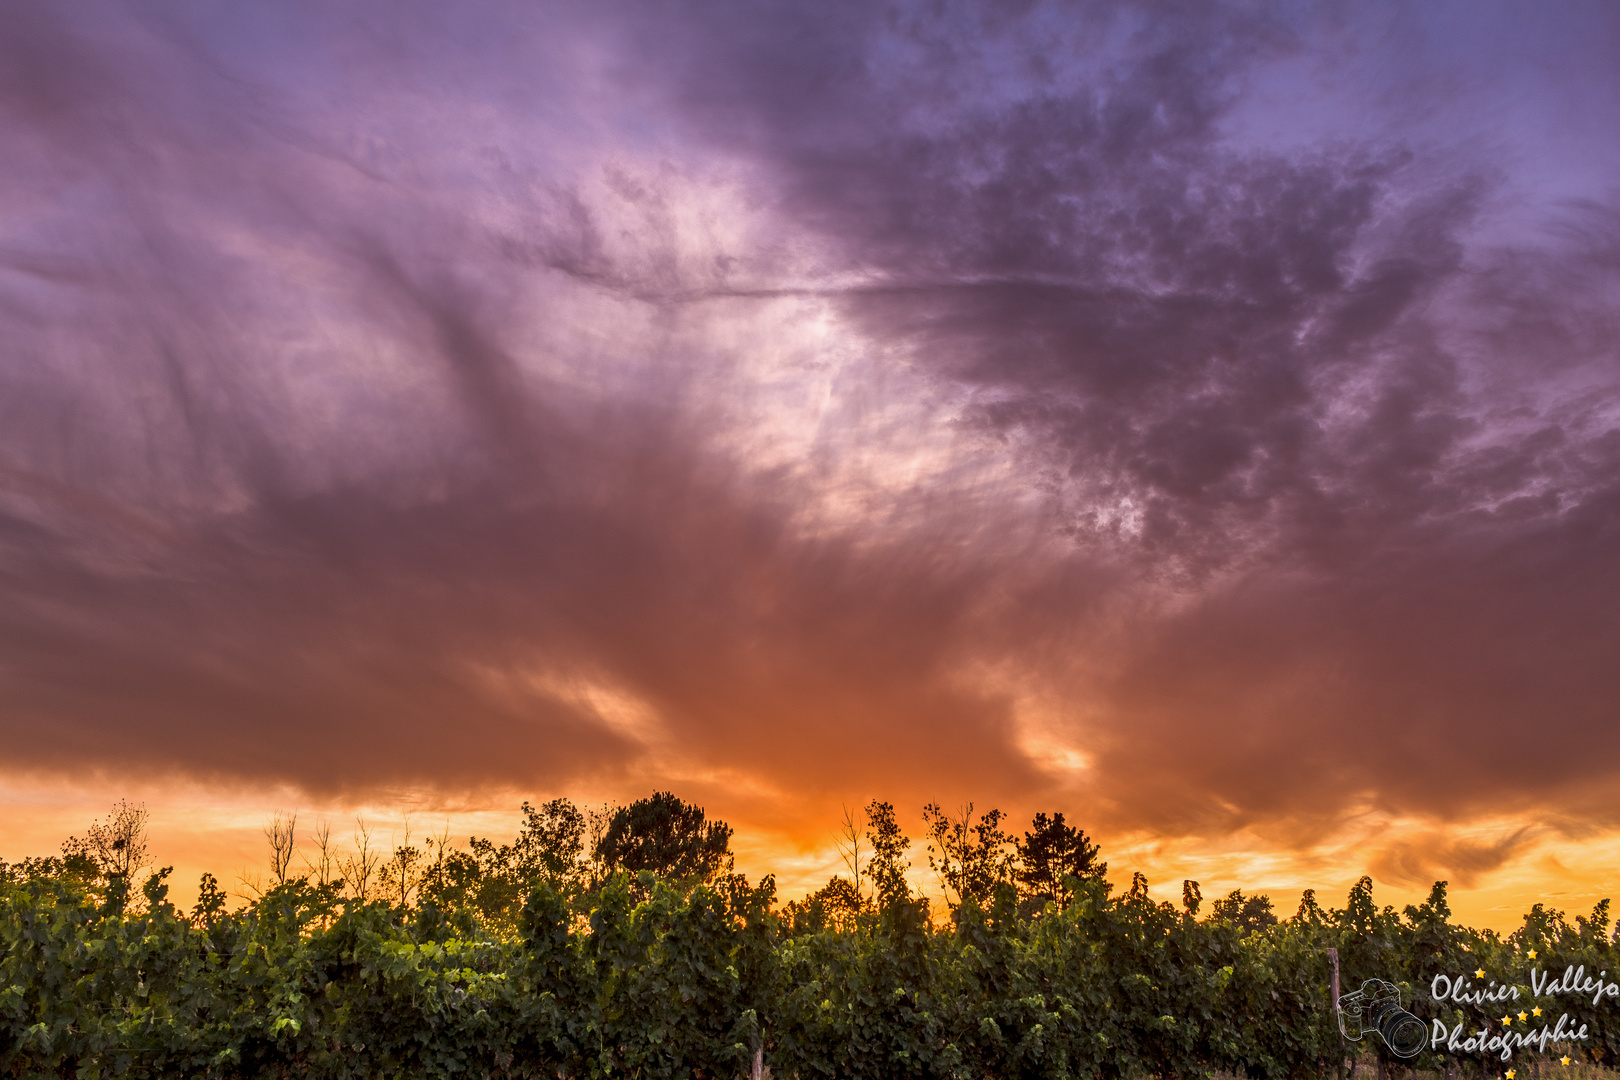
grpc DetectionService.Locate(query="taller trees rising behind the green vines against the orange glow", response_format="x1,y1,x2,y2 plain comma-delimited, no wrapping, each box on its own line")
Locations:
0,792,1108,934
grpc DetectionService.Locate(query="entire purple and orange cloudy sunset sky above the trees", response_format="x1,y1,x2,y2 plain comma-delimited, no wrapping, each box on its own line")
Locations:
0,0,1620,928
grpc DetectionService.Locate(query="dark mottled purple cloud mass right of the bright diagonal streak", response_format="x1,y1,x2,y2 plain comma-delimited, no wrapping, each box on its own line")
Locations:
609,5,1620,841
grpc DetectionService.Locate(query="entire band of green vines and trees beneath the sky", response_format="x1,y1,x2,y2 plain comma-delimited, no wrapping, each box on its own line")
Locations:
0,792,1620,1080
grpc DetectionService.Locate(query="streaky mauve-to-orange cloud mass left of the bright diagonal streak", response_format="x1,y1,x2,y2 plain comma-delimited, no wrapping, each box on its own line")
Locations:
0,0,1062,806
